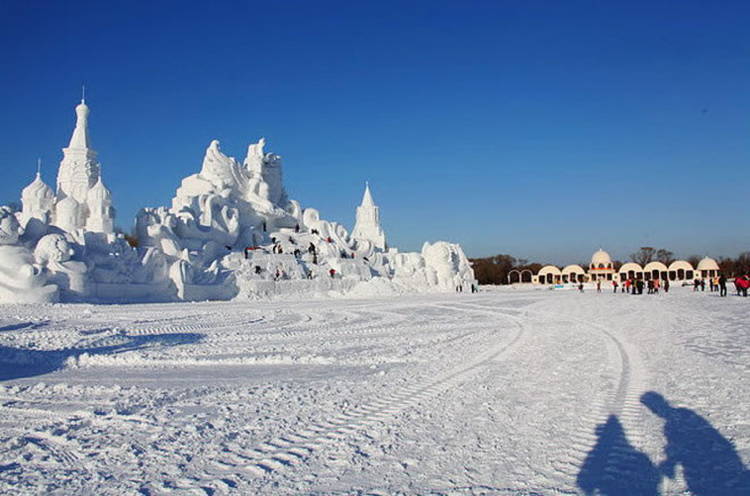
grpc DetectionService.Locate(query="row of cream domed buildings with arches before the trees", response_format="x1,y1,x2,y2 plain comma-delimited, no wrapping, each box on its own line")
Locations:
509,250,720,284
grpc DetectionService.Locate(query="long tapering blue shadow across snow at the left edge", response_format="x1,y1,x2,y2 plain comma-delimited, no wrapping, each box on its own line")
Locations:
0,333,203,381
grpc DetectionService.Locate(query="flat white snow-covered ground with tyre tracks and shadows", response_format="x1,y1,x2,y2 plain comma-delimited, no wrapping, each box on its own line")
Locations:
0,288,750,496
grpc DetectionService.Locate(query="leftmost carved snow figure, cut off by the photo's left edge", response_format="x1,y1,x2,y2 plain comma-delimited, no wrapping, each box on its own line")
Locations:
0,207,58,303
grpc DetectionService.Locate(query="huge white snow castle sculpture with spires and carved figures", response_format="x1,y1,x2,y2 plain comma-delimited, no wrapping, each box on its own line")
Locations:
0,99,475,303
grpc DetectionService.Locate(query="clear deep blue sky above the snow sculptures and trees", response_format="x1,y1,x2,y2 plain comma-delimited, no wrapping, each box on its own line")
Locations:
0,0,750,263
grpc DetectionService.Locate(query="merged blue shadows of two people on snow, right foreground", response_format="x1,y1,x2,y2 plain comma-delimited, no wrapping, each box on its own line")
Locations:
577,391,750,496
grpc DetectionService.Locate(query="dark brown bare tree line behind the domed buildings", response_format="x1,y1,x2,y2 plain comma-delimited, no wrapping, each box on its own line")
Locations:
469,246,750,284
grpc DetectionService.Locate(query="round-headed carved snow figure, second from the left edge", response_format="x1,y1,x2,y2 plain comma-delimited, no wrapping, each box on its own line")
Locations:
34,233,88,300
